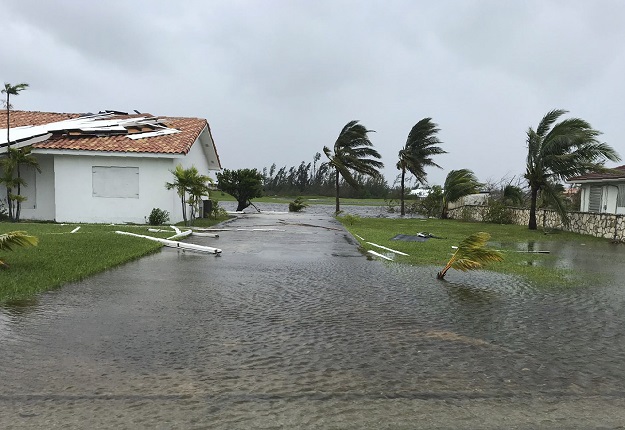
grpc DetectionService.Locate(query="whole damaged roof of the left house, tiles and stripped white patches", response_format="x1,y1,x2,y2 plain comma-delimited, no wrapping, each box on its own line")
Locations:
0,110,217,161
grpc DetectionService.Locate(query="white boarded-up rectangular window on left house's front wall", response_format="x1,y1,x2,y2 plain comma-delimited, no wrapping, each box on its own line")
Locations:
91,166,139,199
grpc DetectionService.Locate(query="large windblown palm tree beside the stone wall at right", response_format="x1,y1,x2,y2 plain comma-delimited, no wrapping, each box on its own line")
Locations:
525,109,620,230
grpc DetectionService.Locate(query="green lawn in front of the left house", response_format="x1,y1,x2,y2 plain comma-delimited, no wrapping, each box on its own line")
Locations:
0,219,229,303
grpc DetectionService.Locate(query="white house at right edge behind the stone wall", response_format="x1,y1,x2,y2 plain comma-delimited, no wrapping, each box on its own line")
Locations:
567,166,625,214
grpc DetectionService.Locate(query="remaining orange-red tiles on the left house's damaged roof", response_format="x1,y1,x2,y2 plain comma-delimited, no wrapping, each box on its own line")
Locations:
0,110,208,154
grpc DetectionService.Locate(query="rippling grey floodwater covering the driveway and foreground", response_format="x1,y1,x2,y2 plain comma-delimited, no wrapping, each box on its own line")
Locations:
0,213,625,429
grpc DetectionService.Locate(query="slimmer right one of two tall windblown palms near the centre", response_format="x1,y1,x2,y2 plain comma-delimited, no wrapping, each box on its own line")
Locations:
397,118,447,216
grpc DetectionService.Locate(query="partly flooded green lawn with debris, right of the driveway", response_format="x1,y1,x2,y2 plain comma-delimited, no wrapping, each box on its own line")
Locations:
339,216,605,287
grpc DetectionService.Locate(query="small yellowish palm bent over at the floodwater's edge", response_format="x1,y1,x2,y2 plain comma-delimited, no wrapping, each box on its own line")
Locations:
436,231,503,279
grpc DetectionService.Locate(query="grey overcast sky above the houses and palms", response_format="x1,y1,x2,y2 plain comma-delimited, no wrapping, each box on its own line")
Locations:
0,0,625,184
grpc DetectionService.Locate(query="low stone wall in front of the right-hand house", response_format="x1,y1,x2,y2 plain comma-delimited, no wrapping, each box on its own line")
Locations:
449,206,625,241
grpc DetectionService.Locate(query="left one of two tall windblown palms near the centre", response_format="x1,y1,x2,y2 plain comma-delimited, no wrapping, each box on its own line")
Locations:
323,120,384,213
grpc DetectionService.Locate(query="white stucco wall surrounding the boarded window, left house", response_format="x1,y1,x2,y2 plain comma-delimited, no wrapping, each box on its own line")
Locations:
54,155,178,223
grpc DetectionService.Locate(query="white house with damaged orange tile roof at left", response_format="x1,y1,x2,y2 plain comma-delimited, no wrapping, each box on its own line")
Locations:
0,111,221,223
